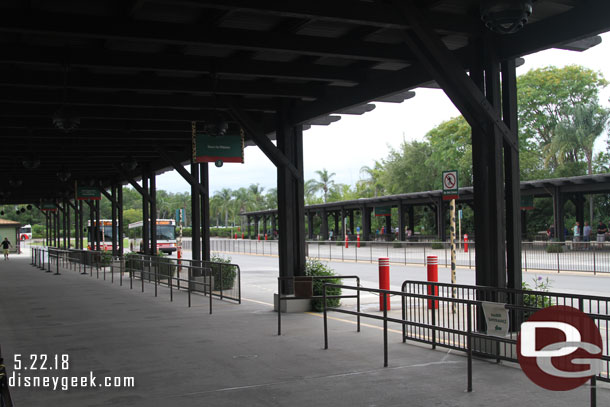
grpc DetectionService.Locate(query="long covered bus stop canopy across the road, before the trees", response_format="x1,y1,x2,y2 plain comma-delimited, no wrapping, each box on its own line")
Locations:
241,174,610,241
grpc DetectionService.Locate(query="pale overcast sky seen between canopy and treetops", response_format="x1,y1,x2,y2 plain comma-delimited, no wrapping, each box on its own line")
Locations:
157,33,610,195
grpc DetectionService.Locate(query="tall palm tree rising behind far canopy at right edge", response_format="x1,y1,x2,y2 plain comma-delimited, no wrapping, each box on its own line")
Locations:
549,102,610,225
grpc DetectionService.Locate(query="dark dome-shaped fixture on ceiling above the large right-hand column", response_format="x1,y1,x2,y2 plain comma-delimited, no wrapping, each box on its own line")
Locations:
481,0,532,34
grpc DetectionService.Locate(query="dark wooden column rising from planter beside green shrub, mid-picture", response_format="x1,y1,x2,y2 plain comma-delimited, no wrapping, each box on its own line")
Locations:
276,105,305,294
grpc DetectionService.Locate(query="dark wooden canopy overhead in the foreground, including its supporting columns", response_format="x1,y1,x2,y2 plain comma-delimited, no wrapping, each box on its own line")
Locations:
0,0,610,294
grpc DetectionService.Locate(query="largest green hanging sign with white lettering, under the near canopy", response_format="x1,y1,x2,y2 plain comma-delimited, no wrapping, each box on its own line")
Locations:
194,131,244,163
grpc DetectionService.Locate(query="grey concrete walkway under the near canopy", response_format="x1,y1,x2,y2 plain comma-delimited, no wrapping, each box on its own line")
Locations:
0,254,610,407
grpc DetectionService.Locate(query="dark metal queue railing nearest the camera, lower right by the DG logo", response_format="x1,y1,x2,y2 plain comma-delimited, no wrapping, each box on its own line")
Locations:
323,282,610,406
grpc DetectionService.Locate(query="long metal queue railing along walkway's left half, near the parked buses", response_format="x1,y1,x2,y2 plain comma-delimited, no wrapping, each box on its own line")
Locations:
31,247,241,314
